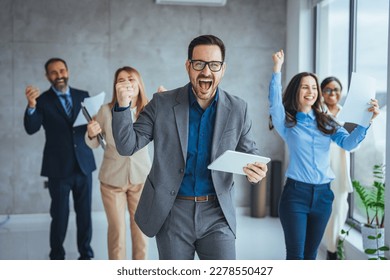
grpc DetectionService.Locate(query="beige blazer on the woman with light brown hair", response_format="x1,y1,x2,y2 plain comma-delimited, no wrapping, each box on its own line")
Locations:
85,104,151,187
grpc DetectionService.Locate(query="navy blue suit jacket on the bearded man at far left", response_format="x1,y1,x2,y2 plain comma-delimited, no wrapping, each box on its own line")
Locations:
24,88,96,178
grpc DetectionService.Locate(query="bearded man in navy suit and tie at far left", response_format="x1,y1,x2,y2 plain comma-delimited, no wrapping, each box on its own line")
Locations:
24,58,96,259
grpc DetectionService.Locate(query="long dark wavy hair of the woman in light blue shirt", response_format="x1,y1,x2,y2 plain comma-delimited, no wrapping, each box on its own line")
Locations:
269,72,337,134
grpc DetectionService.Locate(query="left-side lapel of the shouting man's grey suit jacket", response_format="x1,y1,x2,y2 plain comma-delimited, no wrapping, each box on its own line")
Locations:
173,84,190,161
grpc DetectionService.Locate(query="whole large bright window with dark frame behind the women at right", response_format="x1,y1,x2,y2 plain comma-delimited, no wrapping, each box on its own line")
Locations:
316,0,389,223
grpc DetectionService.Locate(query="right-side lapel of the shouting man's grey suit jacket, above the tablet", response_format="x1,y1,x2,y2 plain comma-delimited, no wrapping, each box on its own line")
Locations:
210,89,231,162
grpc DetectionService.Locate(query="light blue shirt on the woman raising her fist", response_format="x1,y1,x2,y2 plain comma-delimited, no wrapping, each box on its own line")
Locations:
268,72,368,184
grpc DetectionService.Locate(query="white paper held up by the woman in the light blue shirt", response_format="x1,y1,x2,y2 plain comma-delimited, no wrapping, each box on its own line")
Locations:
337,72,376,127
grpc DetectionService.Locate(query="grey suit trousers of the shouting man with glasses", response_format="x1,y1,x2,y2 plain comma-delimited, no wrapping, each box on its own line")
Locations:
156,199,236,260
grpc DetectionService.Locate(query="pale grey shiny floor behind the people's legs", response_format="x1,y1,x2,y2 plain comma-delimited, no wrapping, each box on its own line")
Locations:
0,208,285,260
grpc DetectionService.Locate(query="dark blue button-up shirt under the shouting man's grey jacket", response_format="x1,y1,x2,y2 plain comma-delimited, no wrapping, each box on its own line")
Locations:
179,88,218,196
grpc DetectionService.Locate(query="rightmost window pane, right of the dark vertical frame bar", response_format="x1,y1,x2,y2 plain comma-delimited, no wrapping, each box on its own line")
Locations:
352,0,389,222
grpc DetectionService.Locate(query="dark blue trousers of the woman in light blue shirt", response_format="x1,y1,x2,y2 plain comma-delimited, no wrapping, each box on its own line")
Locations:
279,178,334,260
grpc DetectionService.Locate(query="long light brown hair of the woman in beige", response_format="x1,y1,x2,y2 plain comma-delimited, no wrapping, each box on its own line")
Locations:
108,66,148,118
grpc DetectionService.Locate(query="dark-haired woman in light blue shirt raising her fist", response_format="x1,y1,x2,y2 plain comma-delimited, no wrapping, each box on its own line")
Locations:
269,51,379,260
